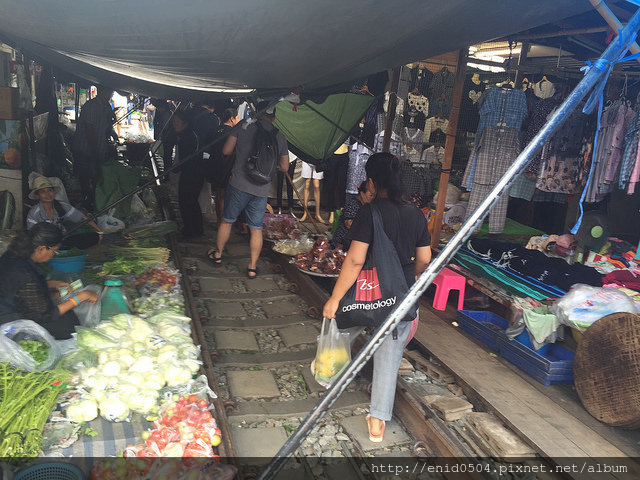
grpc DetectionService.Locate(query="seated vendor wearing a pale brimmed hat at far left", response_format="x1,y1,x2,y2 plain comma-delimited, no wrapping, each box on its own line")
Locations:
27,176,102,250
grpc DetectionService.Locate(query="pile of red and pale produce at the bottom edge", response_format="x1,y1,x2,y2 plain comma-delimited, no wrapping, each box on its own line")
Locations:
124,394,221,457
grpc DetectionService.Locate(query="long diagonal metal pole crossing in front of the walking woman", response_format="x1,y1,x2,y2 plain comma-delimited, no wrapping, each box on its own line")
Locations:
258,10,640,480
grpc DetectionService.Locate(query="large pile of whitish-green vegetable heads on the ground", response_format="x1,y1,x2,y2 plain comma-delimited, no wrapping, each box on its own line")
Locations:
63,311,201,422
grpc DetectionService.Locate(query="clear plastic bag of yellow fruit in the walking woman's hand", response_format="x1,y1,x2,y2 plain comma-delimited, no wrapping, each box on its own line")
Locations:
312,318,351,388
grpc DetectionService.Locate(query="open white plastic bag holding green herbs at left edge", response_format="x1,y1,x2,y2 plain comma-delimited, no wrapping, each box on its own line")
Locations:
0,320,62,372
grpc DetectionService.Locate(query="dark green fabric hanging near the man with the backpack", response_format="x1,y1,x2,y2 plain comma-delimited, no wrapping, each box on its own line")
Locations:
274,93,374,164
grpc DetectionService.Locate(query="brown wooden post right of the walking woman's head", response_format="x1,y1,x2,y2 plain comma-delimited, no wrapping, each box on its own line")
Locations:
431,49,467,248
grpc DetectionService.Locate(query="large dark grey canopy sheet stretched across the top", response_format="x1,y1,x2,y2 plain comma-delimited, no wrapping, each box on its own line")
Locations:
0,0,591,99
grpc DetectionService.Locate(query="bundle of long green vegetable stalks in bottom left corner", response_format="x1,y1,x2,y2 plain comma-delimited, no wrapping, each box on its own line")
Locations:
0,363,69,460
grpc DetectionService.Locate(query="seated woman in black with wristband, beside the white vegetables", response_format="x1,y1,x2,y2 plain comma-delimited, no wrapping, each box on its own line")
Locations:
0,222,98,340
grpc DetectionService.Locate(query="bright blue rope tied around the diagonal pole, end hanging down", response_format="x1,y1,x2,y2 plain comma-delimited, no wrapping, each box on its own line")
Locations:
571,29,640,235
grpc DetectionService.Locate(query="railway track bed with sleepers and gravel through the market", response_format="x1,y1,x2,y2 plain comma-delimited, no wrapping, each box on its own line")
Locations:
173,237,564,479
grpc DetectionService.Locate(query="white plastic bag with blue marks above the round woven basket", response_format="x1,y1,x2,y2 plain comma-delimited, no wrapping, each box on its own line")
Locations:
553,284,638,332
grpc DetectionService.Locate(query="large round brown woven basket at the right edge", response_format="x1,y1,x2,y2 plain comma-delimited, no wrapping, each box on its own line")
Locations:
573,313,640,429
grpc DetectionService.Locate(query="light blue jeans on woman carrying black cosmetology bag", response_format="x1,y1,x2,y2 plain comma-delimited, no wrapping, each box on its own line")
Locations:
342,322,411,422
